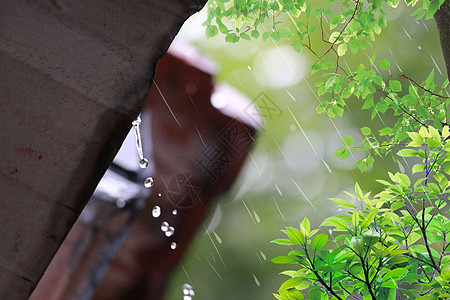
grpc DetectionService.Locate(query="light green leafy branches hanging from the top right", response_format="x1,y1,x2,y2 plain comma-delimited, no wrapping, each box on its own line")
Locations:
203,0,450,172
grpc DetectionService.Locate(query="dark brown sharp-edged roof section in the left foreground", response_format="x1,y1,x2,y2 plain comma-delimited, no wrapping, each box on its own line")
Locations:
0,0,199,299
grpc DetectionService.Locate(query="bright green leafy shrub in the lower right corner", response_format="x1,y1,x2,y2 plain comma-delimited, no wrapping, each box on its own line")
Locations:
272,126,450,299
